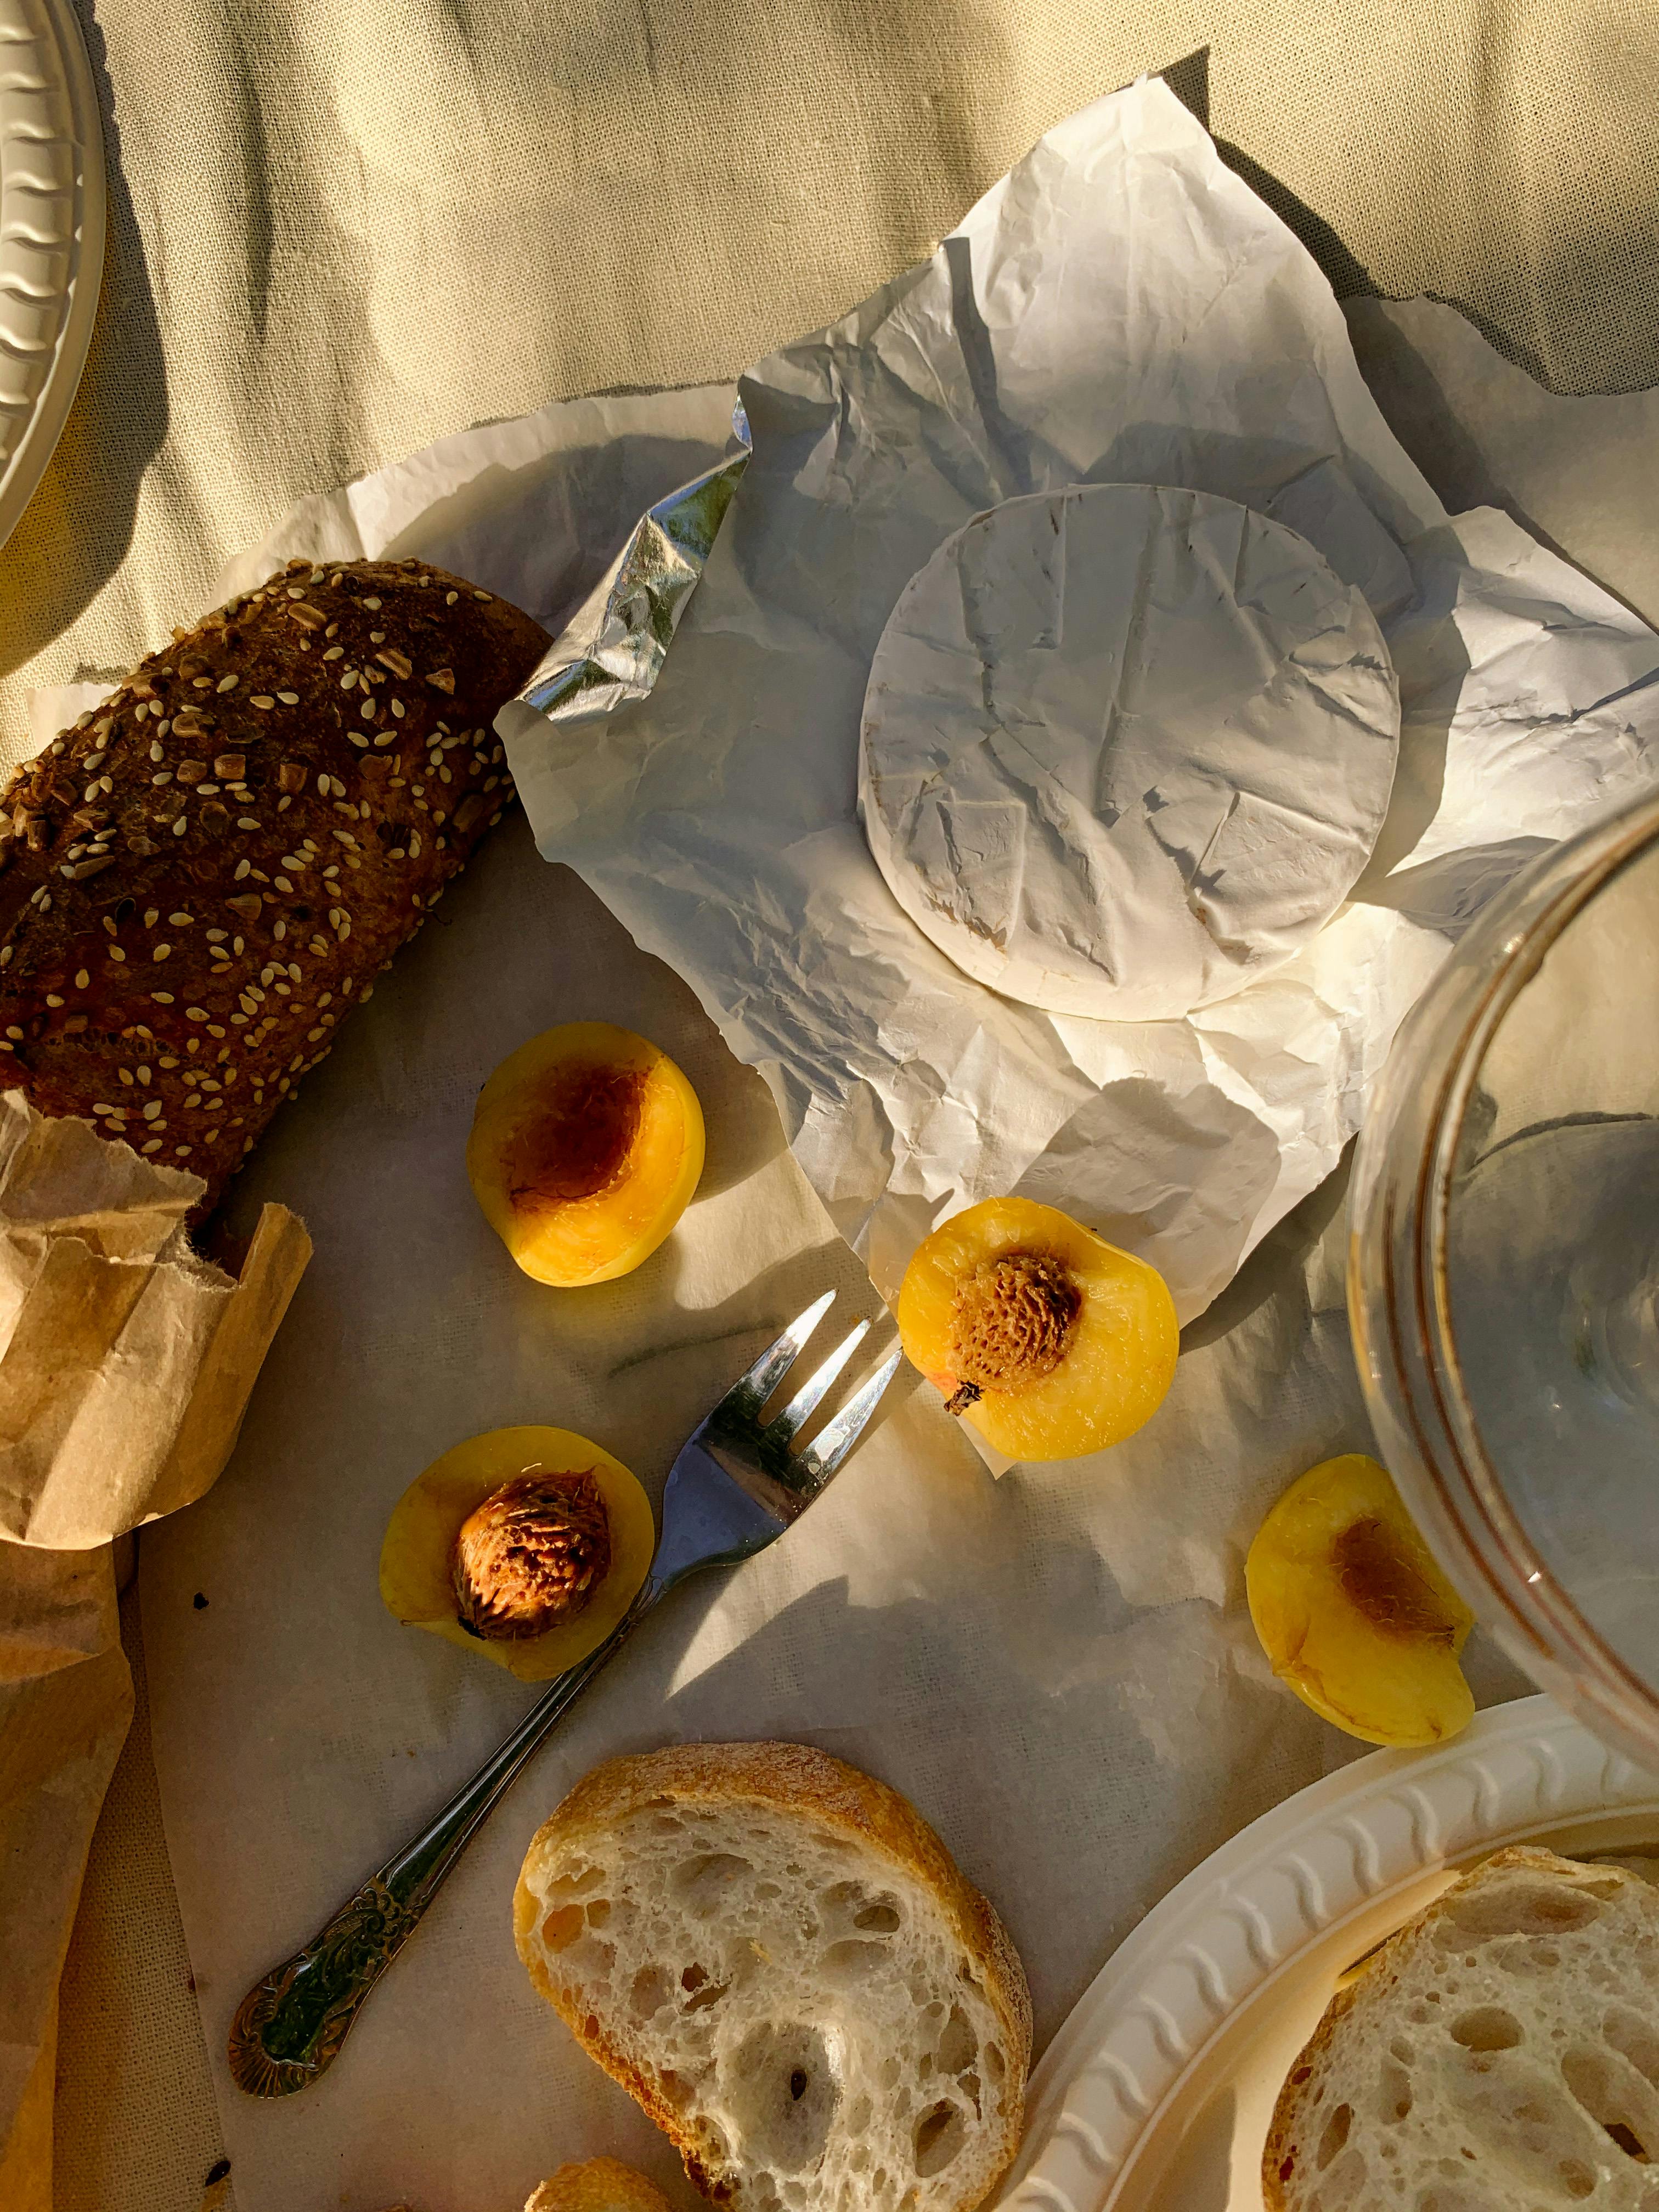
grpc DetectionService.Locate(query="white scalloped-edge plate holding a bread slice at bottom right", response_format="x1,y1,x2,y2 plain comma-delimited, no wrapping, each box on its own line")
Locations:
1000,1697,1659,2212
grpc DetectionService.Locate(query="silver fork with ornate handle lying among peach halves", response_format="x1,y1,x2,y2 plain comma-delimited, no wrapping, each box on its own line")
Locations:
230,1290,900,2097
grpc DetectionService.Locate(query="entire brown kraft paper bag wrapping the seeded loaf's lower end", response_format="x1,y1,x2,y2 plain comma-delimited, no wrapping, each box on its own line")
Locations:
0,1091,312,2212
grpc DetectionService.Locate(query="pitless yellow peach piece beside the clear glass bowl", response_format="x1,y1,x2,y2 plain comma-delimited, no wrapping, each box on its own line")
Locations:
1245,1451,1475,1745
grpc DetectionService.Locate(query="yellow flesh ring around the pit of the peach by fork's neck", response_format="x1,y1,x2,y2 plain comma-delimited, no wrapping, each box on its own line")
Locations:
381,1427,657,1681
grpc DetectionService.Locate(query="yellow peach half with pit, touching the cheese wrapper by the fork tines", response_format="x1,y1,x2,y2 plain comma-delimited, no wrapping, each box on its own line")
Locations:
898,1199,1181,1460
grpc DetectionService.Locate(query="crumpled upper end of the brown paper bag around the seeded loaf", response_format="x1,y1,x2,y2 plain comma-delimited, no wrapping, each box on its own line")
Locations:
0,1091,312,1548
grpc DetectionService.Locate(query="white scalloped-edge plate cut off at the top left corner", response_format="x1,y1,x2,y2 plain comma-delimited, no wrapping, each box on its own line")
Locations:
0,0,104,557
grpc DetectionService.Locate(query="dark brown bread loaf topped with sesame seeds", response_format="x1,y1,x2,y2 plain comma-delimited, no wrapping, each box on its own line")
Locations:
0,560,546,1205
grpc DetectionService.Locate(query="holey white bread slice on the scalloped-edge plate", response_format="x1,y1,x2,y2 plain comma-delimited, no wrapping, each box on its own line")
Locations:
1261,1847,1659,2212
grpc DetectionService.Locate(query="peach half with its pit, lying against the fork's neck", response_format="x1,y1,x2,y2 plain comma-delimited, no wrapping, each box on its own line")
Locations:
381,1427,657,1681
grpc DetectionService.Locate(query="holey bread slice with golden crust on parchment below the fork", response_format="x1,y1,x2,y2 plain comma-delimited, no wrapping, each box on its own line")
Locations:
513,1743,1031,2212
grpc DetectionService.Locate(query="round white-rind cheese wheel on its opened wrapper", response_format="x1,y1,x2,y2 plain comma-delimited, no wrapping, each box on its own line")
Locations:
858,484,1400,1022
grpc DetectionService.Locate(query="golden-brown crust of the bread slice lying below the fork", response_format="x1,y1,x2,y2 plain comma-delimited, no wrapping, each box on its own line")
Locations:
513,1743,1031,2212
